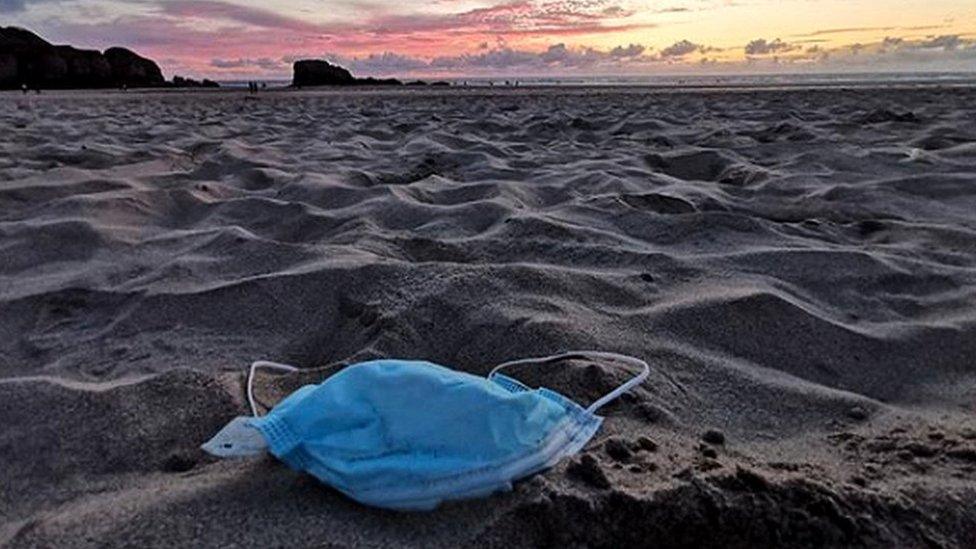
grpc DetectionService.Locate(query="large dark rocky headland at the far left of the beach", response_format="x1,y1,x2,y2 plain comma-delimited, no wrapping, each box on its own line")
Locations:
0,27,166,89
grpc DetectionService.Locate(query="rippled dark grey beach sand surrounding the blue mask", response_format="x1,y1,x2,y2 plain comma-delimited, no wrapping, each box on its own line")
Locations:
0,83,976,547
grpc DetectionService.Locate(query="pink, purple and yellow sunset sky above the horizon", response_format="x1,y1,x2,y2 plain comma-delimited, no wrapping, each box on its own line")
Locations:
0,0,976,79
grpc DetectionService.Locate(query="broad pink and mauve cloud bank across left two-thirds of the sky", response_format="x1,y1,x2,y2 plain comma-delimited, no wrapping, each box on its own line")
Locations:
32,0,650,73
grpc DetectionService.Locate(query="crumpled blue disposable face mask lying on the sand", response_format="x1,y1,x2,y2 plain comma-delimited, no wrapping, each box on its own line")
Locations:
202,352,649,510
